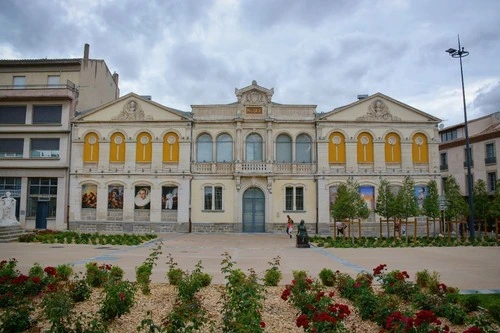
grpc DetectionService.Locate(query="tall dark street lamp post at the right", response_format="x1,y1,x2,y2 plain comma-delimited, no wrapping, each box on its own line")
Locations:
446,35,475,238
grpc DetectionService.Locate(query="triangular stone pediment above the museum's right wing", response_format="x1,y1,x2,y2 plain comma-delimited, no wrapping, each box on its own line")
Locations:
318,93,441,123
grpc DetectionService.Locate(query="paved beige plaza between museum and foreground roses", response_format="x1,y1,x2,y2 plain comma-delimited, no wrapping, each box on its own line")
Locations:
0,233,500,293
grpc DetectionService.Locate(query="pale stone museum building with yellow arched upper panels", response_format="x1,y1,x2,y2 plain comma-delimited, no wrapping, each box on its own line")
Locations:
69,81,441,233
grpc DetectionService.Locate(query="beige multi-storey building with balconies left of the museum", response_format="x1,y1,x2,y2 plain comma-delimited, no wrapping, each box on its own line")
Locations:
0,44,119,229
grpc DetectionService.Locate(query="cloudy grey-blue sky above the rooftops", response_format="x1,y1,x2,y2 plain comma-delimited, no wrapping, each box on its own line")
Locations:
0,0,500,126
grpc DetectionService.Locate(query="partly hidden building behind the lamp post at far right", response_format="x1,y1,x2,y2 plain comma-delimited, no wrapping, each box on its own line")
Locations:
439,112,500,196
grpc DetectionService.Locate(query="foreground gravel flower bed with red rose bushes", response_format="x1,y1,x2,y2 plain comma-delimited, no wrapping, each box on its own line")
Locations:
0,253,500,333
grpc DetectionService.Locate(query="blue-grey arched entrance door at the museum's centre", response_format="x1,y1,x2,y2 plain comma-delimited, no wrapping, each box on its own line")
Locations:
243,187,266,232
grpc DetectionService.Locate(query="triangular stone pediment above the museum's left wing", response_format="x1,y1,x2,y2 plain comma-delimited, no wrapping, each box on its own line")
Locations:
75,93,190,122
